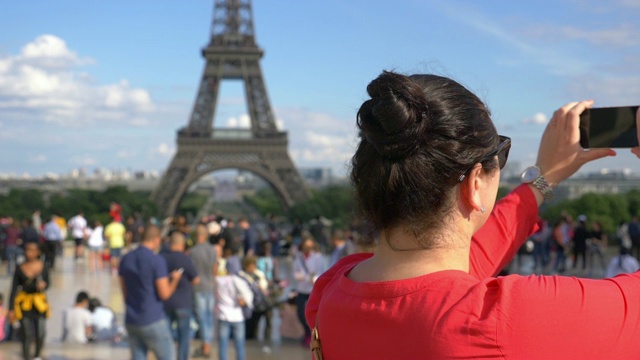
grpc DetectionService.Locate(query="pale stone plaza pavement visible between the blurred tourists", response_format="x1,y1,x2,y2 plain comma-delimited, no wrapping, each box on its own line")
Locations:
0,244,311,360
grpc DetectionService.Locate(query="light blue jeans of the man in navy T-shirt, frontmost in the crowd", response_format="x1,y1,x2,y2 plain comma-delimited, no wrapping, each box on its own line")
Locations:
127,319,176,360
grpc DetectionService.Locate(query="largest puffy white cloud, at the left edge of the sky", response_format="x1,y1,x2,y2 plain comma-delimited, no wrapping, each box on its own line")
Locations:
0,35,155,126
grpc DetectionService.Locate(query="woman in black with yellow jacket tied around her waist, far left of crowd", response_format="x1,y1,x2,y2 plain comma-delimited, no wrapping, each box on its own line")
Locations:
9,243,51,359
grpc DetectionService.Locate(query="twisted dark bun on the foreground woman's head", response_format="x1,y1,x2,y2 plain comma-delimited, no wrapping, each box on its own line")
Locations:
357,71,427,159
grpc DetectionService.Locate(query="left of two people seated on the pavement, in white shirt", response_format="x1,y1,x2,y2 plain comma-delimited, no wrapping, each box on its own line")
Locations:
62,291,92,344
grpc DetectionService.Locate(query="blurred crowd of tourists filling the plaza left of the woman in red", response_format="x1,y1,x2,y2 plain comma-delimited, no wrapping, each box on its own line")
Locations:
0,203,357,359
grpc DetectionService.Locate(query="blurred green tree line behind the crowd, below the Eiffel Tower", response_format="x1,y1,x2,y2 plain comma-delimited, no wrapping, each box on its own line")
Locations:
0,185,640,238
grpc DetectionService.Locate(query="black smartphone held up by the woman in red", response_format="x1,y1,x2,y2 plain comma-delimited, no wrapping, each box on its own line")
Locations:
580,106,638,149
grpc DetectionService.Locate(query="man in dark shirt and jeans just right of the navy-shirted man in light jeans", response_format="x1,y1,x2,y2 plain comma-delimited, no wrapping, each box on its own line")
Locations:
162,231,200,360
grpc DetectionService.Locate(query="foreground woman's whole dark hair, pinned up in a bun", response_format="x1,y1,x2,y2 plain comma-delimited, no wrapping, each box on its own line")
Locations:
351,71,499,249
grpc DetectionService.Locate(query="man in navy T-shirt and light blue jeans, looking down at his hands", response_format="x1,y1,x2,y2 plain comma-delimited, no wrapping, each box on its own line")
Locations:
118,225,182,360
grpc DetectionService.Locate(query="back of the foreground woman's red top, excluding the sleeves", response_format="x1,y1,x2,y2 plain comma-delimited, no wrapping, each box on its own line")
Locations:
318,255,488,359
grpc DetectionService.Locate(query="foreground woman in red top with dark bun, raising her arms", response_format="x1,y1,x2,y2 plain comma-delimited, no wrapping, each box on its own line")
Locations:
306,72,640,360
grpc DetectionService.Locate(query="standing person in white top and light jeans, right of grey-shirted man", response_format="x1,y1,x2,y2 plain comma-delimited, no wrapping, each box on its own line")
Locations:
216,271,253,360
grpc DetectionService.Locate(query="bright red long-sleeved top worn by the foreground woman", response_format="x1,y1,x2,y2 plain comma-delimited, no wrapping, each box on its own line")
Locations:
306,186,640,360
